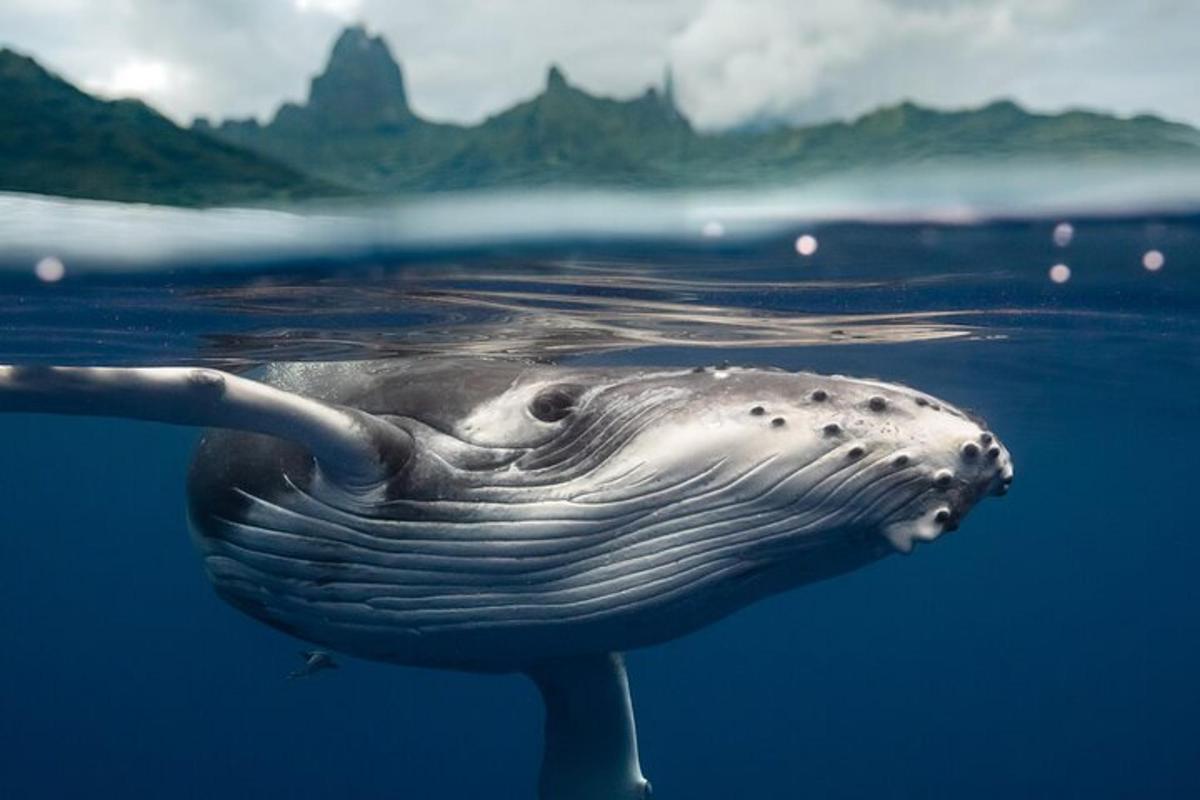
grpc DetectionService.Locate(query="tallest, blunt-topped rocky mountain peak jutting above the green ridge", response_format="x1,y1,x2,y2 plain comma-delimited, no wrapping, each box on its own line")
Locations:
277,25,413,130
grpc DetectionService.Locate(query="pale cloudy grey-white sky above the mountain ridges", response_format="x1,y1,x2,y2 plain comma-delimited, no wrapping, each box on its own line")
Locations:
0,0,1200,130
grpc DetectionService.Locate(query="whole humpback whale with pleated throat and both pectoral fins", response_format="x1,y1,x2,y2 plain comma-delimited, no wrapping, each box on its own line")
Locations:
0,359,1013,800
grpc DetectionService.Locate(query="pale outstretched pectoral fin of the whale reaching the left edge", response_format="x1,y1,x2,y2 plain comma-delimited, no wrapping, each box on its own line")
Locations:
0,366,412,488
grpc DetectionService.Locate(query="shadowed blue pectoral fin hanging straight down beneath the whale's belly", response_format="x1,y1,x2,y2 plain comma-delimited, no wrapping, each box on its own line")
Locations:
528,652,650,800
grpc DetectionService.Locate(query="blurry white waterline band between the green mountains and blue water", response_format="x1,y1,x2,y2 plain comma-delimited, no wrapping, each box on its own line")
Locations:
0,163,1200,272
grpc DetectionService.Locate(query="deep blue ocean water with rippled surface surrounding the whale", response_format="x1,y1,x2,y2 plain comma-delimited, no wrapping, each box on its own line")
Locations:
0,190,1200,800
